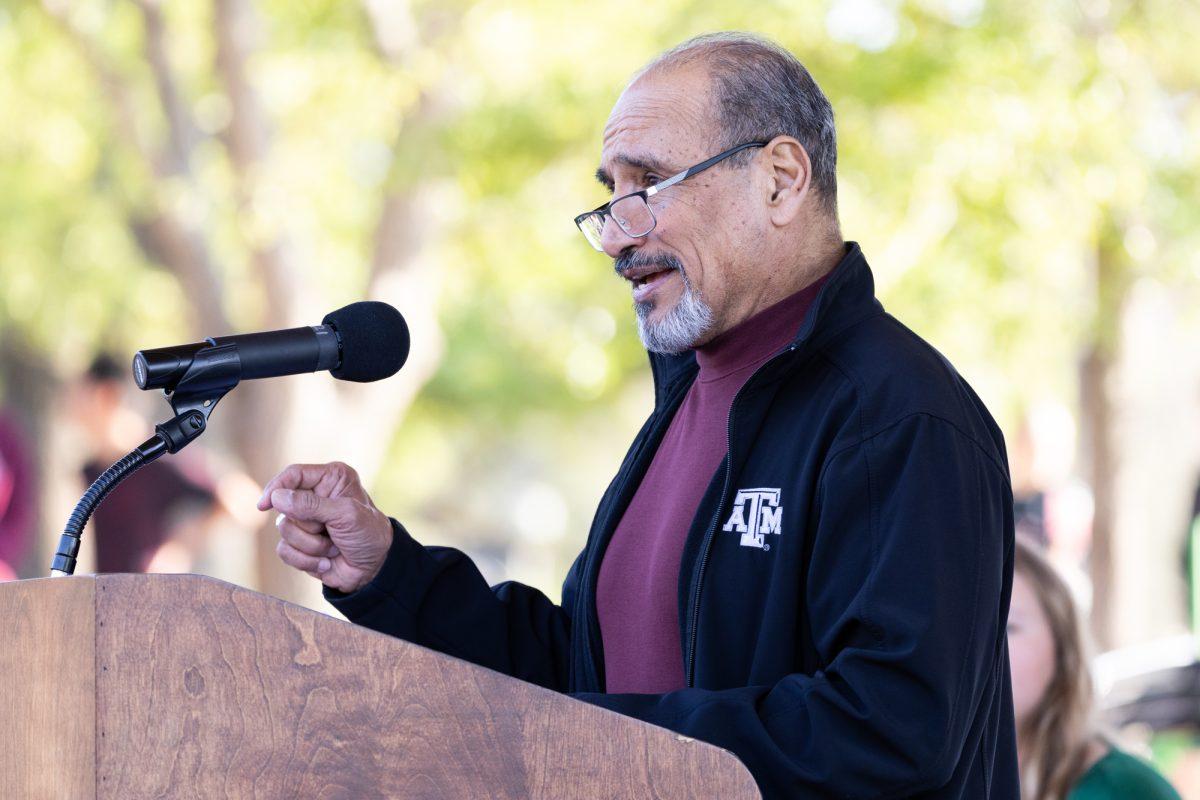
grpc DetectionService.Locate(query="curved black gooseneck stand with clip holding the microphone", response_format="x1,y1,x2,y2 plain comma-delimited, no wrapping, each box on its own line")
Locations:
50,344,241,577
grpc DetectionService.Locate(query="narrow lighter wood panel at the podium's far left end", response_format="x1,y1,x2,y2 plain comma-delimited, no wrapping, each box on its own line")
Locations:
0,578,96,800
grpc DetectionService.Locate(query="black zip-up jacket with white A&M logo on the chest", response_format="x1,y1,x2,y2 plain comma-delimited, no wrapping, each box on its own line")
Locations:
326,243,1019,800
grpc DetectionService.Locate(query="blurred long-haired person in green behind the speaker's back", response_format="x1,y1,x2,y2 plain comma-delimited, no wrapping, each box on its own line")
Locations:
1008,536,1180,800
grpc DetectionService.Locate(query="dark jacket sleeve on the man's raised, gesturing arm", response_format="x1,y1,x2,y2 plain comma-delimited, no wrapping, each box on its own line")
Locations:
324,519,576,691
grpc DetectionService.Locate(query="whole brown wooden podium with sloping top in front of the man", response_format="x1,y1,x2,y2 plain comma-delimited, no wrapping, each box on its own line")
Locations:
0,575,760,800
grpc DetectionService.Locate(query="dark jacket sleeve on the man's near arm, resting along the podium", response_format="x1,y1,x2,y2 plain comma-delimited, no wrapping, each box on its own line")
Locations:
577,415,1012,799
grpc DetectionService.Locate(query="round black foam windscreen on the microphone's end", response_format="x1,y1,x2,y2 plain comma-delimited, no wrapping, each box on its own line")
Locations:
320,300,409,384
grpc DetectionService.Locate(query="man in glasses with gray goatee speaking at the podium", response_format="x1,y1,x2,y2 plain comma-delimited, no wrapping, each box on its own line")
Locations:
259,34,1018,800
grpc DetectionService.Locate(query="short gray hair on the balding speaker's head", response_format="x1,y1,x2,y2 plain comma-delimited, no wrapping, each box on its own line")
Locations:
631,31,838,216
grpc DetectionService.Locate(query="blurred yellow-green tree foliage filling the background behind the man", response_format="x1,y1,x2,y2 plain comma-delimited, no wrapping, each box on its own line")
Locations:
0,0,1200,582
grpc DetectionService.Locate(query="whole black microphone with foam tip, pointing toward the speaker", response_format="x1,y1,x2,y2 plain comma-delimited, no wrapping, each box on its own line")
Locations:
133,301,409,391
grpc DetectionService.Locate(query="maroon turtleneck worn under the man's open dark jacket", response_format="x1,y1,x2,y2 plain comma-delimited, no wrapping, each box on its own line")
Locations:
596,276,828,693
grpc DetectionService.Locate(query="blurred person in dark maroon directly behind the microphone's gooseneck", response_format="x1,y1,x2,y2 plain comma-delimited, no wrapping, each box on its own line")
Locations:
68,354,226,572
